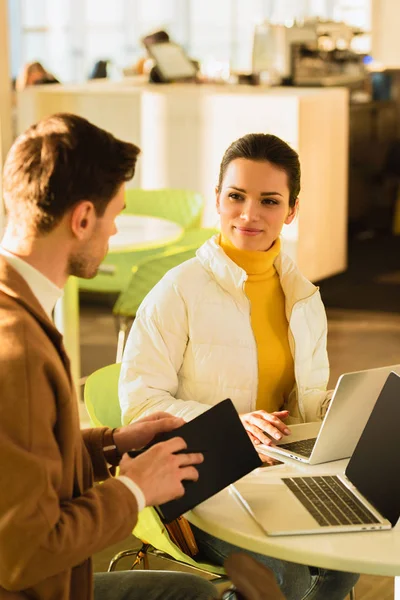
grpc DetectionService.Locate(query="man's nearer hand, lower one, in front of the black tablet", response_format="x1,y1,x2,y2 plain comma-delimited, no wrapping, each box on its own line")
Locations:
119,437,204,506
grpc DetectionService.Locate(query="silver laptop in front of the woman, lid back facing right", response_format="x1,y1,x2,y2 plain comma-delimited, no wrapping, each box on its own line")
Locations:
257,365,400,465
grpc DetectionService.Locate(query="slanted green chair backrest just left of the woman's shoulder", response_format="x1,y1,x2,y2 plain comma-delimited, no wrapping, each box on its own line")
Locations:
113,245,197,318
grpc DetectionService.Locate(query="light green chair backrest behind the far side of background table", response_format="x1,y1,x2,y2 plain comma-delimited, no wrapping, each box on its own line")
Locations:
125,189,204,229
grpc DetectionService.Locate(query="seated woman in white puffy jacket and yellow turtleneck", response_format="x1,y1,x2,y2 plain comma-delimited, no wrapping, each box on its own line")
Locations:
120,134,357,600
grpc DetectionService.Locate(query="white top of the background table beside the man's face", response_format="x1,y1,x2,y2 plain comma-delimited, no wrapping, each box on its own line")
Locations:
109,215,183,252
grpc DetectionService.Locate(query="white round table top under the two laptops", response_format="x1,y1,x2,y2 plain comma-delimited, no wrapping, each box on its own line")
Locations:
186,459,400,576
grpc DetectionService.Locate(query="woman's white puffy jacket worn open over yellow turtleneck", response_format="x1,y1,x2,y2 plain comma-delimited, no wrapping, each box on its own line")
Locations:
119,236,329,423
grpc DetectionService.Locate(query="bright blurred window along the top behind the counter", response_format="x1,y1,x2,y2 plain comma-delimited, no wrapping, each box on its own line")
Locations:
8,0,371,82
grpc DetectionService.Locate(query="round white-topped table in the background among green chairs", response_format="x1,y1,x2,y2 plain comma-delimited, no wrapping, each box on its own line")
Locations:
54,214,184,394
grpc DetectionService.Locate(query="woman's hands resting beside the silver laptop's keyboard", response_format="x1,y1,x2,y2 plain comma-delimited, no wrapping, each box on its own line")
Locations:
240,410,290,446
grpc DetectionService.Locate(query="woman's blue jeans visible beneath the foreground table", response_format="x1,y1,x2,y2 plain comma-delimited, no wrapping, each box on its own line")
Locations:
192,525,359,600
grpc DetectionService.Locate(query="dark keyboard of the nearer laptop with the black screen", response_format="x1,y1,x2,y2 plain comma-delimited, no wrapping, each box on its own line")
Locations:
282,475,379,527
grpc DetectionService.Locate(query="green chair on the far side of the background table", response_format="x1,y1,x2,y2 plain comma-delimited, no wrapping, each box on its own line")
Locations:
79,189,204,294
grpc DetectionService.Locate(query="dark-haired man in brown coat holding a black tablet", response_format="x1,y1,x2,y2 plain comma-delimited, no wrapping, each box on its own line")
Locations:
0,114,215,600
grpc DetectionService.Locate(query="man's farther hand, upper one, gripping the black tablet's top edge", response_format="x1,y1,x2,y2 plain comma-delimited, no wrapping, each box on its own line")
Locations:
114,412,185,455
